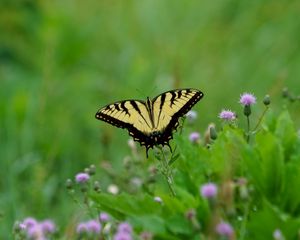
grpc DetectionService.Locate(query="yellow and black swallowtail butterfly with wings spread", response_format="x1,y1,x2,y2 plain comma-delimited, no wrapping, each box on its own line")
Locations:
95,88,203,157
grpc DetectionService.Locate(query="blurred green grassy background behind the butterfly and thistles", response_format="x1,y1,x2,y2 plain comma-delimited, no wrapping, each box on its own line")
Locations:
0,0,300,236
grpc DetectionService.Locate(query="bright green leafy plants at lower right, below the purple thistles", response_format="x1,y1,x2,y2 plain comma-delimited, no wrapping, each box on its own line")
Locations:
89,111,300,239
